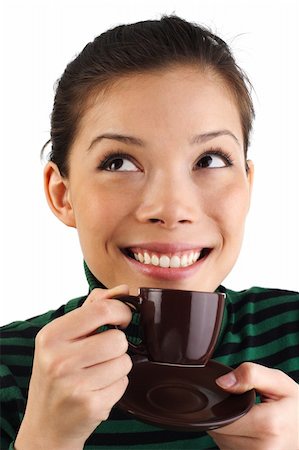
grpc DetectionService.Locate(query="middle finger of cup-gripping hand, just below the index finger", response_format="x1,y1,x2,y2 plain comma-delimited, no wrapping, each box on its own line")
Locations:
73,329,128,368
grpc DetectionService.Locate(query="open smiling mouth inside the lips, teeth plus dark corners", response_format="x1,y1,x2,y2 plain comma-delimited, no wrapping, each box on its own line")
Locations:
124,247,210,269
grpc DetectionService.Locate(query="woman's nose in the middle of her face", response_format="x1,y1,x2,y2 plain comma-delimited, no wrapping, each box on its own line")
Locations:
136,171,201,229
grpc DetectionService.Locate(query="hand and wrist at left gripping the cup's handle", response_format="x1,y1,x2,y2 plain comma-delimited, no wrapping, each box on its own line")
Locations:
15,285,132,450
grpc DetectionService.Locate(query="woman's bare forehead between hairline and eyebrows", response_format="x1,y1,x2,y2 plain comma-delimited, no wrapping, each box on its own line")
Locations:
77,66,242,146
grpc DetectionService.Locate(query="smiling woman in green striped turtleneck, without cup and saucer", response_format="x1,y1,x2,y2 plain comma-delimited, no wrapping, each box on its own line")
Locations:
1,16,299,450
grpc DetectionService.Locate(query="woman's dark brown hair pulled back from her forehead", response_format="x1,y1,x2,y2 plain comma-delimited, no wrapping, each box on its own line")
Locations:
43,16,254,177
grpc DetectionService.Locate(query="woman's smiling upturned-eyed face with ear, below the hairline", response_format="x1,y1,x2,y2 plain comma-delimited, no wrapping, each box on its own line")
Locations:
45,67,252,293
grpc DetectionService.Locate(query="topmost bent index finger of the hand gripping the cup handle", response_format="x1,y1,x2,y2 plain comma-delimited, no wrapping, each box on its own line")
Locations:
41,285,132,343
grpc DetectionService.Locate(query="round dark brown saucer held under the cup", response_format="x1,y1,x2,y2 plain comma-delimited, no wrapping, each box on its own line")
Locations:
118,356,255,431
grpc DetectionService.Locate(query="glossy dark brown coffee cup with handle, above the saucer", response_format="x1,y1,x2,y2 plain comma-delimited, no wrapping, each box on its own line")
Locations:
117,287,225,366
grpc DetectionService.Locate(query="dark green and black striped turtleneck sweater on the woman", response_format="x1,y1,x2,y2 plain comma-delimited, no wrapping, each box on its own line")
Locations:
0,265,299,450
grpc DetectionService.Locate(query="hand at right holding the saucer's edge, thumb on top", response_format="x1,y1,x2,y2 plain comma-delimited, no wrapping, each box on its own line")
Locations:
209,363,299,450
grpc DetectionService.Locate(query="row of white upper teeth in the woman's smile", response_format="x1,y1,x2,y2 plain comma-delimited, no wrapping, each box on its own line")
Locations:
134,251,201,268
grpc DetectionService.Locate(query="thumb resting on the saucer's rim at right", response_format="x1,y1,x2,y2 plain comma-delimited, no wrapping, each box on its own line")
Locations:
216,362,298,400
